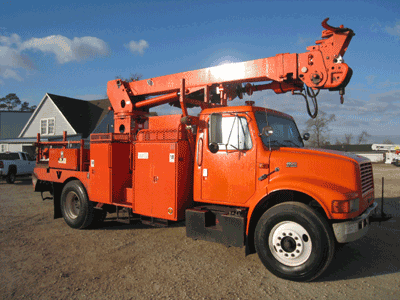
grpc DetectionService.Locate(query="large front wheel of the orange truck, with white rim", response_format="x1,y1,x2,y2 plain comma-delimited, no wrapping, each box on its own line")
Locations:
255,202,335,281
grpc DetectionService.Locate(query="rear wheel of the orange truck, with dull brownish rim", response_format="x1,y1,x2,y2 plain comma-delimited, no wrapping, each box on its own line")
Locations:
60,180,95,229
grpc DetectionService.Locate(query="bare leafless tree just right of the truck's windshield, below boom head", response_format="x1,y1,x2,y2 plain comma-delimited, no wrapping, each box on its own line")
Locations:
306,111,336,147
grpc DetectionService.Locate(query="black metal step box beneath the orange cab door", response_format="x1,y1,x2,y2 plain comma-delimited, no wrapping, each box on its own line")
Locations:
186,206,247,247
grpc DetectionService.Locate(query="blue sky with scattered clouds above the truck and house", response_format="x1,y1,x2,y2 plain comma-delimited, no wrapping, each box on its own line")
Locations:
0,0,400,143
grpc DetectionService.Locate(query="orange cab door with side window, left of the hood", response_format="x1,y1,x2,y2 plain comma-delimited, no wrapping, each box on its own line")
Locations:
201,114,256,204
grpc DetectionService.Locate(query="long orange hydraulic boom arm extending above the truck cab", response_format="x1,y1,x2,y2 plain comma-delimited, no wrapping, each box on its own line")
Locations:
107,18,354,132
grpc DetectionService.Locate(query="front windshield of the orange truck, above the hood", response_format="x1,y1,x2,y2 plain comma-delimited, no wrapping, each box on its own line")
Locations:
255,111,304,147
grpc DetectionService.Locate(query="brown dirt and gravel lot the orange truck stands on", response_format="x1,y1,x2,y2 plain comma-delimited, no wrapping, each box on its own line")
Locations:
0,164,400,299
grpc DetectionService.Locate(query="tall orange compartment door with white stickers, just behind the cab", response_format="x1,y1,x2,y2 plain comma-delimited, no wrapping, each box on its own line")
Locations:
135,143,178,220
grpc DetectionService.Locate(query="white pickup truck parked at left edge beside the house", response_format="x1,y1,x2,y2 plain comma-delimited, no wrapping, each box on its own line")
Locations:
0,152,36,183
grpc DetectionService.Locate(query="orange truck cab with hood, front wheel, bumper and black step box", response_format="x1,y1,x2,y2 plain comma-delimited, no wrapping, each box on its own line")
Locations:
186,103,377,280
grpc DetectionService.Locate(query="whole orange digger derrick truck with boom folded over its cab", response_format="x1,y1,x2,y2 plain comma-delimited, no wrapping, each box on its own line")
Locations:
33,19,377,281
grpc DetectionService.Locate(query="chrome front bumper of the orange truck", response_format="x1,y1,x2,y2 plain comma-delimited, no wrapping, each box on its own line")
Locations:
332,202,378,243
